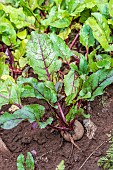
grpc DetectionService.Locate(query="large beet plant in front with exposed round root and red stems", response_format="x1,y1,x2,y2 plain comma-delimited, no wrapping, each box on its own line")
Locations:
0,32,113,146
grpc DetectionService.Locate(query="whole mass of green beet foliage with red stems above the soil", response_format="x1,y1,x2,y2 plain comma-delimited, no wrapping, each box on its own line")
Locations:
0,0,113,136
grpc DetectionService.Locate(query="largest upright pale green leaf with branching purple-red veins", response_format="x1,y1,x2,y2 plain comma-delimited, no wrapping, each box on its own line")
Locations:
27,32,61,81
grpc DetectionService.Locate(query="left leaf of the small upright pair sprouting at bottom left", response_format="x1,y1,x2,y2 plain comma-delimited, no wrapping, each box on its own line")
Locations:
17,153,25,170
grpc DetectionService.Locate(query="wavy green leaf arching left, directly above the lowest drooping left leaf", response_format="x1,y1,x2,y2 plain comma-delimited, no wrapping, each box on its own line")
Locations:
18,77,57,104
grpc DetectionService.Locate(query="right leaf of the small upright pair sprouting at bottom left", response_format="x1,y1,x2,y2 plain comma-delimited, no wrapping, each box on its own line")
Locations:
26,152,35,170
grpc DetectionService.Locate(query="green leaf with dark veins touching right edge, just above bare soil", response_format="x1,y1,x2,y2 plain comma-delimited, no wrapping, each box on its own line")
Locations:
80,69,113,100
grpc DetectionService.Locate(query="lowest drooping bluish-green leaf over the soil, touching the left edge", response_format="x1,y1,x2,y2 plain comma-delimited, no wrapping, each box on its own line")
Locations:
0,104,45,129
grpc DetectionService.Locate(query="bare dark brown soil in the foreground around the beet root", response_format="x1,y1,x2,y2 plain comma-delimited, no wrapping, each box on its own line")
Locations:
0,85,113,170
